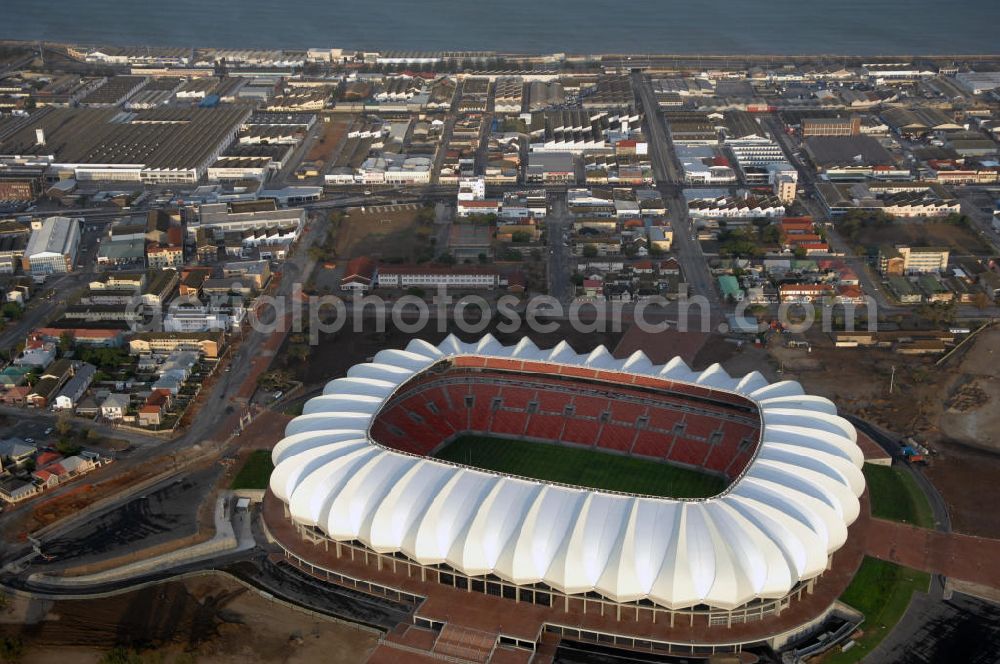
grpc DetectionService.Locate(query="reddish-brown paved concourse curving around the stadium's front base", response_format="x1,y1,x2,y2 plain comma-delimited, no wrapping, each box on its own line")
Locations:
262,491,871,662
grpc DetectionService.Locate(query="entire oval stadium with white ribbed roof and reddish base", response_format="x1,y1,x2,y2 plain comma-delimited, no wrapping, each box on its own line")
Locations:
264,335,865,661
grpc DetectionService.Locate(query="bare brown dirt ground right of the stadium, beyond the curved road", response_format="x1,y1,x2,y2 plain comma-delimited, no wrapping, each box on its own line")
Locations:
769,327,1000,537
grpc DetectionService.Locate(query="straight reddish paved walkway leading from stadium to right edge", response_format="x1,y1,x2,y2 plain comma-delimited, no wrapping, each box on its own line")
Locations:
867,519,1000,590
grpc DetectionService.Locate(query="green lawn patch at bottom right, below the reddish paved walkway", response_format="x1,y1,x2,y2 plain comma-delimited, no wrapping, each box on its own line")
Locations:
821,557,931,664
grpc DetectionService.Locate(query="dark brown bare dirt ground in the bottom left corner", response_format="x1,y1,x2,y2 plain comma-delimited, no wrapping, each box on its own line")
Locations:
0,576,377,664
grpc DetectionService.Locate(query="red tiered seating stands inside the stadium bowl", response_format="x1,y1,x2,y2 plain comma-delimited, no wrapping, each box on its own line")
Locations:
372,365,759,478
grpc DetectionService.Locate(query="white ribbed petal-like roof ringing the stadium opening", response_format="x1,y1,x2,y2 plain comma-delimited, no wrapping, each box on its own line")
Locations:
270,335,865,609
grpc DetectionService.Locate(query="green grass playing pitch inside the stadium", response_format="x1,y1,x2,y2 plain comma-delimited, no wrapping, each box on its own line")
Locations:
434,436,727,498
